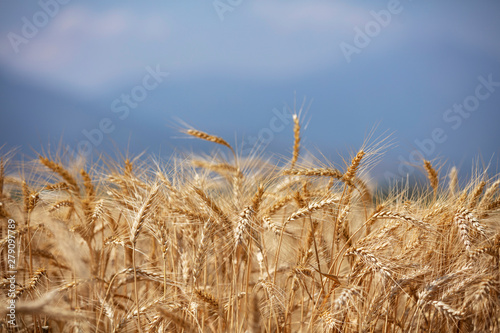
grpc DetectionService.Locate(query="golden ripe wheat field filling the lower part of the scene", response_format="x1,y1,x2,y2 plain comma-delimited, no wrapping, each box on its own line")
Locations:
0,116,500,333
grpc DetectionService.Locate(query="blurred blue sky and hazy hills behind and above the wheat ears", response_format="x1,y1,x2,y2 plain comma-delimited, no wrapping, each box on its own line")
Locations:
0,0,500,182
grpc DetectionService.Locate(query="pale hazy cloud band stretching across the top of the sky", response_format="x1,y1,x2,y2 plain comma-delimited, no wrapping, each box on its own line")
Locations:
0,0,500,95
